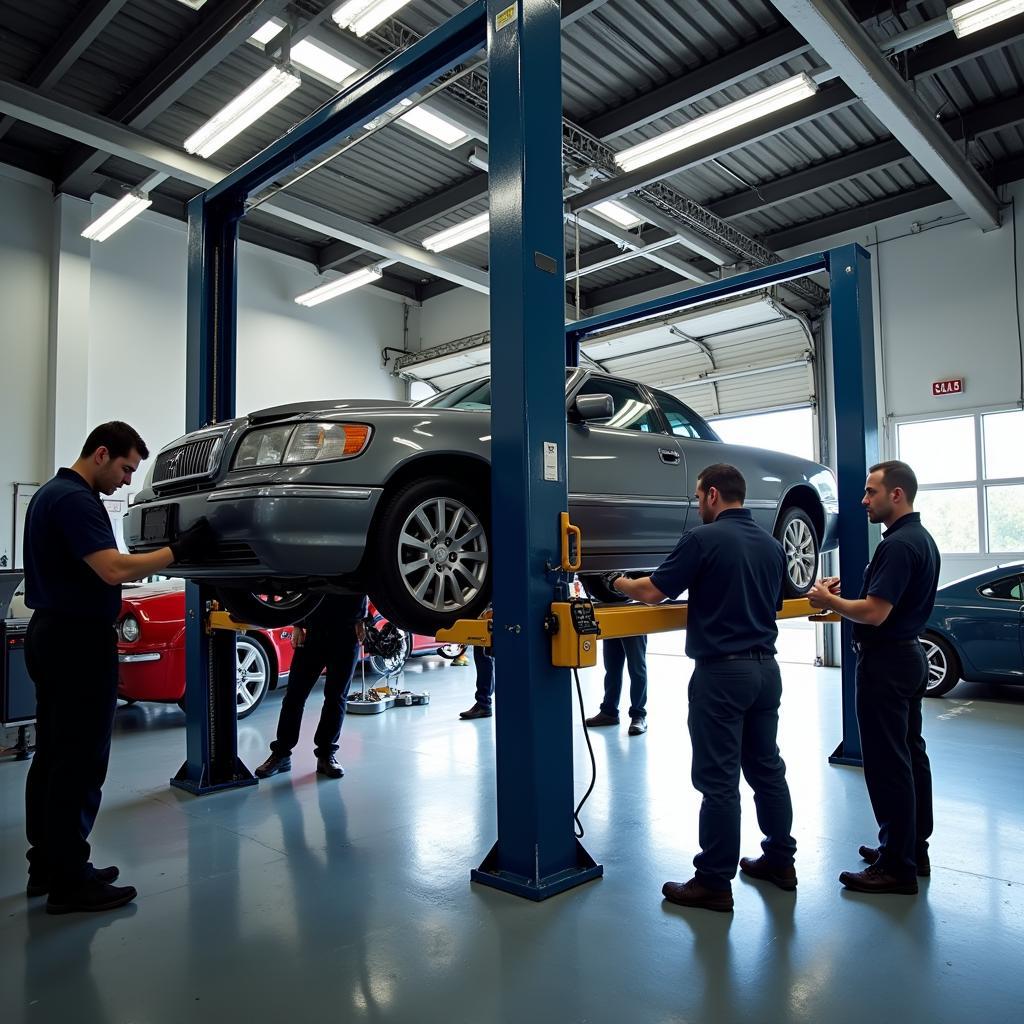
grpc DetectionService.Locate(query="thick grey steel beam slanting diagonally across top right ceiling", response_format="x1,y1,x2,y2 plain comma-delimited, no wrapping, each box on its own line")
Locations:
771,0,999,230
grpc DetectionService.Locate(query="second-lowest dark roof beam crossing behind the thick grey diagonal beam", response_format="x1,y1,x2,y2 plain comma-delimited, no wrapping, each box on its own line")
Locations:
709,95,1024,219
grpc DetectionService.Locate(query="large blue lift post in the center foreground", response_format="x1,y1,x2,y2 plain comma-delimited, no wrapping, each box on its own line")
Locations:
471,0,602,900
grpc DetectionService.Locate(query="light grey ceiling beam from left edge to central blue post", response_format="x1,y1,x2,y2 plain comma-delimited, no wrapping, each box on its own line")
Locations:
0,80,487,292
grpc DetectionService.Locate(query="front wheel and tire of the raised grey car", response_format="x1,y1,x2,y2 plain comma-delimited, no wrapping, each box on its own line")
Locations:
370,476,490,636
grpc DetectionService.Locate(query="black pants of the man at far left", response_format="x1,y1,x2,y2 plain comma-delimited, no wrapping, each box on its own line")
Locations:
25,610,118,891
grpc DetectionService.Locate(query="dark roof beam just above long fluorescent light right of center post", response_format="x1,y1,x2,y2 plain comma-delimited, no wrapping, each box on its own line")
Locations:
583,26,811,140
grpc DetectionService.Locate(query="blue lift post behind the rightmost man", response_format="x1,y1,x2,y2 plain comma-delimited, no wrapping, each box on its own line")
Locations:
827,245,879,765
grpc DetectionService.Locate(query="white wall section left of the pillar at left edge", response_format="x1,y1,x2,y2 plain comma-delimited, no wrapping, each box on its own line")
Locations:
0,176,53,567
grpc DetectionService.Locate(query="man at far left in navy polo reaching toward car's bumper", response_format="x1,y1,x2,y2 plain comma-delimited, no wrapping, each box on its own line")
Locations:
25,422,211,913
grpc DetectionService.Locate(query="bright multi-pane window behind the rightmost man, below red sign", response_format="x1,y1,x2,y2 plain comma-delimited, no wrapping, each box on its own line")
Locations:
896,410,1024,556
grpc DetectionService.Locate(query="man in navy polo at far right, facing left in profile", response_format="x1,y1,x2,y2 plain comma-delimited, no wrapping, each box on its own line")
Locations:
808,461,940,895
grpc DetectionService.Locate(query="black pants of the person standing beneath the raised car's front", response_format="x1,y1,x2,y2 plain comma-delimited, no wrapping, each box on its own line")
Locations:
270,622,359,758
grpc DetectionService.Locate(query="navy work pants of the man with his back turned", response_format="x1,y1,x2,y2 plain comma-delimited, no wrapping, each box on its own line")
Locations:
688,658,797,889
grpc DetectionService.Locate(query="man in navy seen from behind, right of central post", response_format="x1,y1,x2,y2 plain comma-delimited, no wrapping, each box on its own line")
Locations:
609,464,797,911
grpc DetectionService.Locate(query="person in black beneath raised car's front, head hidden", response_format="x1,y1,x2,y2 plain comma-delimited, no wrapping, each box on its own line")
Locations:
256,594,368,778
